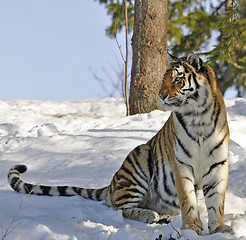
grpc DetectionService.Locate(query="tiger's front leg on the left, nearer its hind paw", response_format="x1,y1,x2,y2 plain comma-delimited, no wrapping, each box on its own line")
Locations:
173,160,202,234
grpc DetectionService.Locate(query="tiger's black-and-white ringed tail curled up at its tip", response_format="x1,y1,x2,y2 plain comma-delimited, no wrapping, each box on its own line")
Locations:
8,165,108,201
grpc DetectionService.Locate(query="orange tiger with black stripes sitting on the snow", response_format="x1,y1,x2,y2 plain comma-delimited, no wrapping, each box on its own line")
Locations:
8,53,234,235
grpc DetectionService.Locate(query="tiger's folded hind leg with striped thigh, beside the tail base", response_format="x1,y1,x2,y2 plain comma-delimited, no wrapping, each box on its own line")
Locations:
107,144,170,223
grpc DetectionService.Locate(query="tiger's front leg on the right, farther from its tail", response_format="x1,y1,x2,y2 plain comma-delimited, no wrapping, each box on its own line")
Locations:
203,160,234,234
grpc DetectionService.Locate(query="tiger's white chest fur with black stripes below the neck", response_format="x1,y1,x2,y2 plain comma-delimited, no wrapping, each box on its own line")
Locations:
174,104,228,188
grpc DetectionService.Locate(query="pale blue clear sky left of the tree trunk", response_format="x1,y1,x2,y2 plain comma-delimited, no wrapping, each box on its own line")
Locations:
0,0,124,100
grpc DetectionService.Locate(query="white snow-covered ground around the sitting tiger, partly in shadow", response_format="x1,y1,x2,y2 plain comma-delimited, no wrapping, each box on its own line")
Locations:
0,98,246,240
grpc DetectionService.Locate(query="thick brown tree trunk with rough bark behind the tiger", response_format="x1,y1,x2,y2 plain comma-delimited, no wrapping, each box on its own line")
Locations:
129,0,168,115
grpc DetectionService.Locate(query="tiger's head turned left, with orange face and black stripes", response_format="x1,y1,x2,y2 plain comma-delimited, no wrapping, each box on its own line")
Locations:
159,53,217,111
